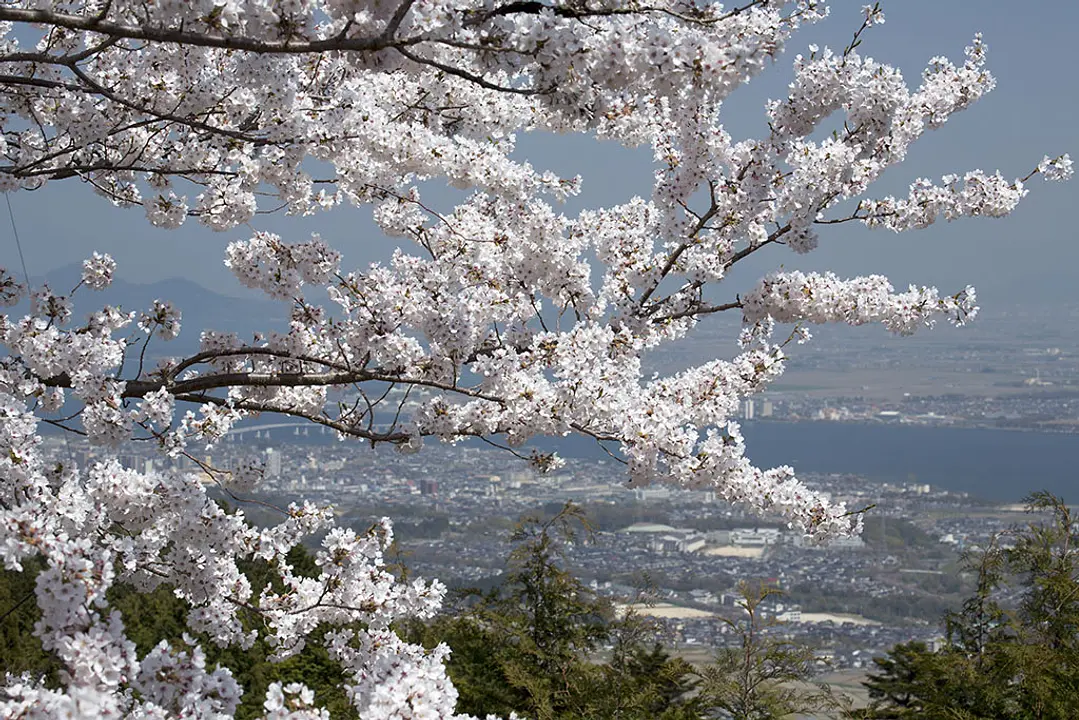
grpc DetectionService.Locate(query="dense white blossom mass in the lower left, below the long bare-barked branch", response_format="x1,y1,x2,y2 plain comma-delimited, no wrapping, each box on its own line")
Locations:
0,427,472,719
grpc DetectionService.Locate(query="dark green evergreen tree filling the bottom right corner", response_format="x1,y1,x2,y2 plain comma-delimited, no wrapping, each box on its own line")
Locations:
865,493,1079,720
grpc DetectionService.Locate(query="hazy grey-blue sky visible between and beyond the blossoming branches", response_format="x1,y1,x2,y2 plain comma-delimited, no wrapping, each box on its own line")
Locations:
0,0,1079,310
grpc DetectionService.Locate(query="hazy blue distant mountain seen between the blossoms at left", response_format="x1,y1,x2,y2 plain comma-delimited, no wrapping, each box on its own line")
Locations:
41,264,288,355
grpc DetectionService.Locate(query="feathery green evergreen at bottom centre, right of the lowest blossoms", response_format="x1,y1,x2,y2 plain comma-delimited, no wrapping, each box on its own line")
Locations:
402,503,701,720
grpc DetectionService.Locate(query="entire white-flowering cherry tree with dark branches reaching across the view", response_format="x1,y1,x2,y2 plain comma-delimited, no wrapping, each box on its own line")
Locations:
0,0,1071,718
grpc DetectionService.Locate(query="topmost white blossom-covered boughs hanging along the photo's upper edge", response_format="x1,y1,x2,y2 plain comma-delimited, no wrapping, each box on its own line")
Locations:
0,0,823,229
